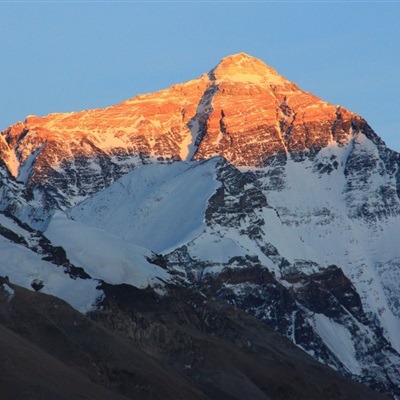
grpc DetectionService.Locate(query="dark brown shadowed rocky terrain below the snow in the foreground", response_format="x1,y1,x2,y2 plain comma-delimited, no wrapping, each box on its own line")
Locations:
0,282,385,400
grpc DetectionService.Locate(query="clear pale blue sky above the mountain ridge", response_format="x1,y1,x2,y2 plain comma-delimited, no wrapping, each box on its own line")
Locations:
0,0,400,151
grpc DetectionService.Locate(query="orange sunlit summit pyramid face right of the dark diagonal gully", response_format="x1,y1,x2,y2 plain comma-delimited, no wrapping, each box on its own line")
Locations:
191,54,356,166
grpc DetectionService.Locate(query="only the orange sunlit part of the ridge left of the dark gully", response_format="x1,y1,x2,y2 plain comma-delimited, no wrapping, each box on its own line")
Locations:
2,78,207,167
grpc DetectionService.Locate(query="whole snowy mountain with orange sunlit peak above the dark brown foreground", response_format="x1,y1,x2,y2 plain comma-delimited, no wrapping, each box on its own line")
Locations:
0,53,400,398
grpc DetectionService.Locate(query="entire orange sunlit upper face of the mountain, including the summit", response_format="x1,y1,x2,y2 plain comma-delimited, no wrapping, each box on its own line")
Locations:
0,53,355,186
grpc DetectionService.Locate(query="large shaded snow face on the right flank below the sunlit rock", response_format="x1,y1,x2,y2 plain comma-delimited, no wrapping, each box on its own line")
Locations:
252,139,400,351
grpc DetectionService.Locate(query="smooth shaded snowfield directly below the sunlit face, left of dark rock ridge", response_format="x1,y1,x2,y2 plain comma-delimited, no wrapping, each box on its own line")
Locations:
69,158,220,253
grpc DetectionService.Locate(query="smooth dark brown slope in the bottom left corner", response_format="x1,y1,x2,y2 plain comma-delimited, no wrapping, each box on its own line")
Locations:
0,282,211,399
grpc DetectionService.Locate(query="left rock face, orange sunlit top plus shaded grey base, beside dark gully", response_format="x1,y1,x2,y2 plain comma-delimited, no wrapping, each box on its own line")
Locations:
0,70,209,212
